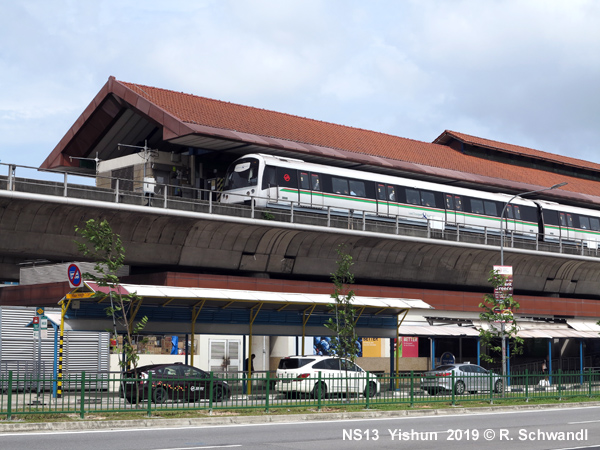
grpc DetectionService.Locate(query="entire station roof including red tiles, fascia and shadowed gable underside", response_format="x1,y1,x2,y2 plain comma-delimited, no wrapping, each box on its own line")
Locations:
41,77,600,204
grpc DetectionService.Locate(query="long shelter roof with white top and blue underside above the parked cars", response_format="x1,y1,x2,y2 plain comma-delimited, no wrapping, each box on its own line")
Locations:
61,281,432,337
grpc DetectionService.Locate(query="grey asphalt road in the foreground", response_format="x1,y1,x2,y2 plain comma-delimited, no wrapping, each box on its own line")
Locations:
0,407,600,450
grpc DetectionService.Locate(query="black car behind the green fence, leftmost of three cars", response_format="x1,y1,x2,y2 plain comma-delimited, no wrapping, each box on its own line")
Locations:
120,363,231,403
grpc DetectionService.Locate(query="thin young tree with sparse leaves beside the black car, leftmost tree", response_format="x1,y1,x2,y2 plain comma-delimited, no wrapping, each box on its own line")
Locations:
75,219,148,378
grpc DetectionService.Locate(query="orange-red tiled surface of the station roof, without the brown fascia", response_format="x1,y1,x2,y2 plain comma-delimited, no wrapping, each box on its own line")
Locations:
120,82,600,196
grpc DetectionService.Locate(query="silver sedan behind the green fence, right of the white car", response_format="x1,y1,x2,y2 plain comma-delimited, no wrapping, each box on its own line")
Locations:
421,363,504,395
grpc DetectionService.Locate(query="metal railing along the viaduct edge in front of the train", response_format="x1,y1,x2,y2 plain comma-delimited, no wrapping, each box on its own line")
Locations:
0,163,599,257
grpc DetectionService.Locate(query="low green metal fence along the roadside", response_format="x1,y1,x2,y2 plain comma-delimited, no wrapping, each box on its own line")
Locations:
0,371,600,420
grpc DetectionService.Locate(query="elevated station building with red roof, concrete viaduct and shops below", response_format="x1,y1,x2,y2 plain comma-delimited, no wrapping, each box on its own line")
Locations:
0,77,600,371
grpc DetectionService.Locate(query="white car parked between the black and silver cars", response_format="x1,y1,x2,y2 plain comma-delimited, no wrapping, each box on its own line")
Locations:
275,356,381,398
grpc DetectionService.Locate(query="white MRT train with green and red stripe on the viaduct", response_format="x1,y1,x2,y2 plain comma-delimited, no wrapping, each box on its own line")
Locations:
220,154,600,249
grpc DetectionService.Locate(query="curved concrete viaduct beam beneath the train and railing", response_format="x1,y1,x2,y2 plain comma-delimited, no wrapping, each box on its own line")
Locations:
0,191,600,297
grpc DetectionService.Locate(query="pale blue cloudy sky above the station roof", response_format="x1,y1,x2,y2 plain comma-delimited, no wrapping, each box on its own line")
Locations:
0,0,600,175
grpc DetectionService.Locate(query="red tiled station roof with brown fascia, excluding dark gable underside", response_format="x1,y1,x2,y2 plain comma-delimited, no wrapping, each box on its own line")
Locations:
42,77,600,204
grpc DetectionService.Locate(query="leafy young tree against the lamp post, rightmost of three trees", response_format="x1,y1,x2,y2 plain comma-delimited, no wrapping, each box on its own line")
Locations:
479,269,523,375
